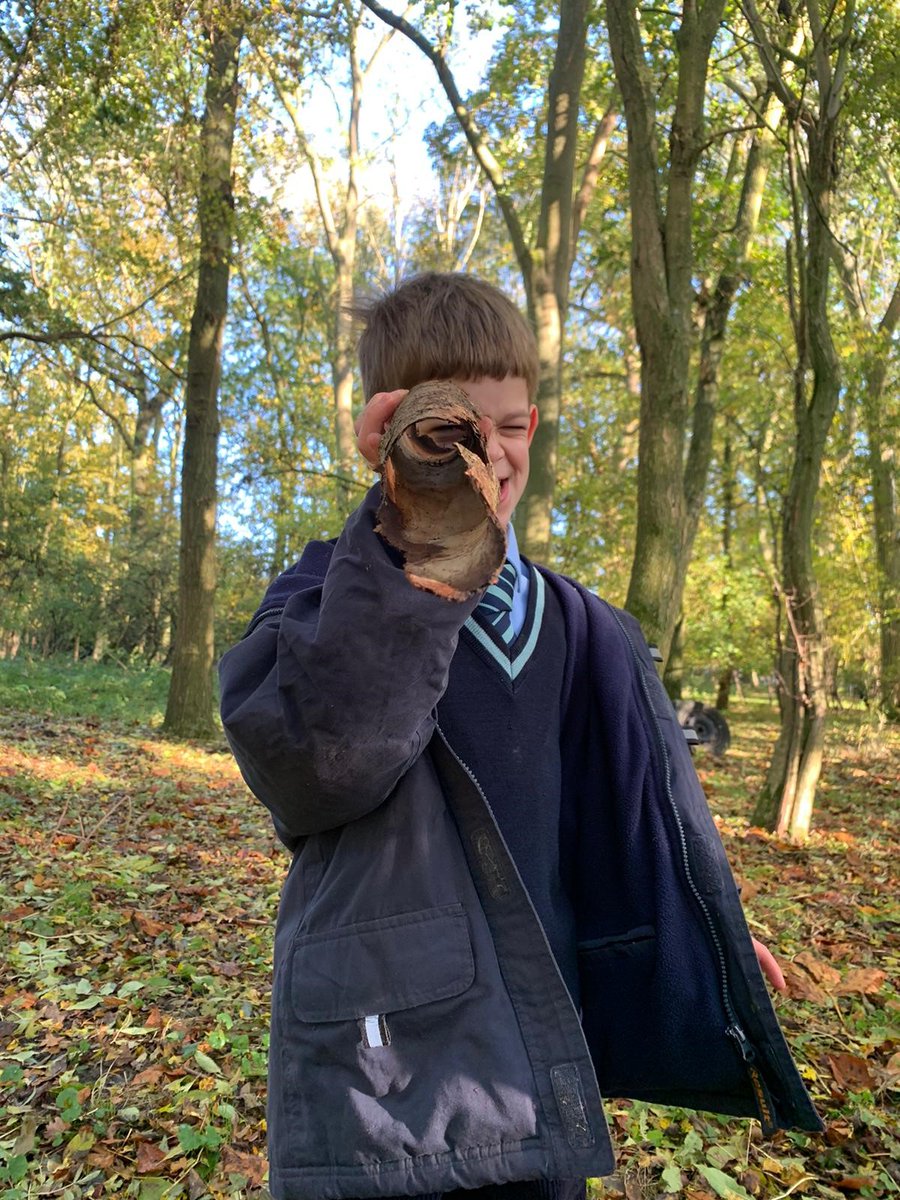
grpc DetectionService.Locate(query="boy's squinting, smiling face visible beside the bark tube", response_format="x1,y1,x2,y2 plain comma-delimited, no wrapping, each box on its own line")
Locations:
454,376,538,526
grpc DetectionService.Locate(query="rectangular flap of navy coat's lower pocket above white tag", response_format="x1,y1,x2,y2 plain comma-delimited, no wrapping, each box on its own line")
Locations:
290,904,475,1022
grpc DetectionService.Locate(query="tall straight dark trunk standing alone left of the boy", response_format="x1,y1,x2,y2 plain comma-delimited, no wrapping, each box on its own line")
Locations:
163,8,241,737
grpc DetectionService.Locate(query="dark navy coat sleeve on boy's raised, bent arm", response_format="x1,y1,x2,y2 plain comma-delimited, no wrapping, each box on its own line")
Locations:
220,487,478,844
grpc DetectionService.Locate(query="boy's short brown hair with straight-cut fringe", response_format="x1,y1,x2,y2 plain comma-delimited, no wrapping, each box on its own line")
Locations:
353,271,539,400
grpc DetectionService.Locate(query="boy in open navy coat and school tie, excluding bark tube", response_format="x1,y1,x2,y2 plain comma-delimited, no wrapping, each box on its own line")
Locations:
221,274,820,1200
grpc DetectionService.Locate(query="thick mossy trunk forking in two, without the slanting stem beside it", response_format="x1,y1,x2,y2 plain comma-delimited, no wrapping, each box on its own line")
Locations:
606,0,725,661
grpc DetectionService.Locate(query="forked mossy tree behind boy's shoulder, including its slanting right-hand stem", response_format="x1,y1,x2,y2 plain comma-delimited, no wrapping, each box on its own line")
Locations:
607,0,799,660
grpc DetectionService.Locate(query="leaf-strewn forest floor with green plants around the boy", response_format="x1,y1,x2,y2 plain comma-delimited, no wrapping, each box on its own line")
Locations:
0,664,900,1200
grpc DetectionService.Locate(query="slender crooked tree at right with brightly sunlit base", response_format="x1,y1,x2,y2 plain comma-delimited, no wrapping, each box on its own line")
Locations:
745,0,854,840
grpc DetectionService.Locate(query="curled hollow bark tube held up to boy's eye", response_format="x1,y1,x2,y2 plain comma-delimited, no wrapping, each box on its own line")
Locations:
378,379,506,600
